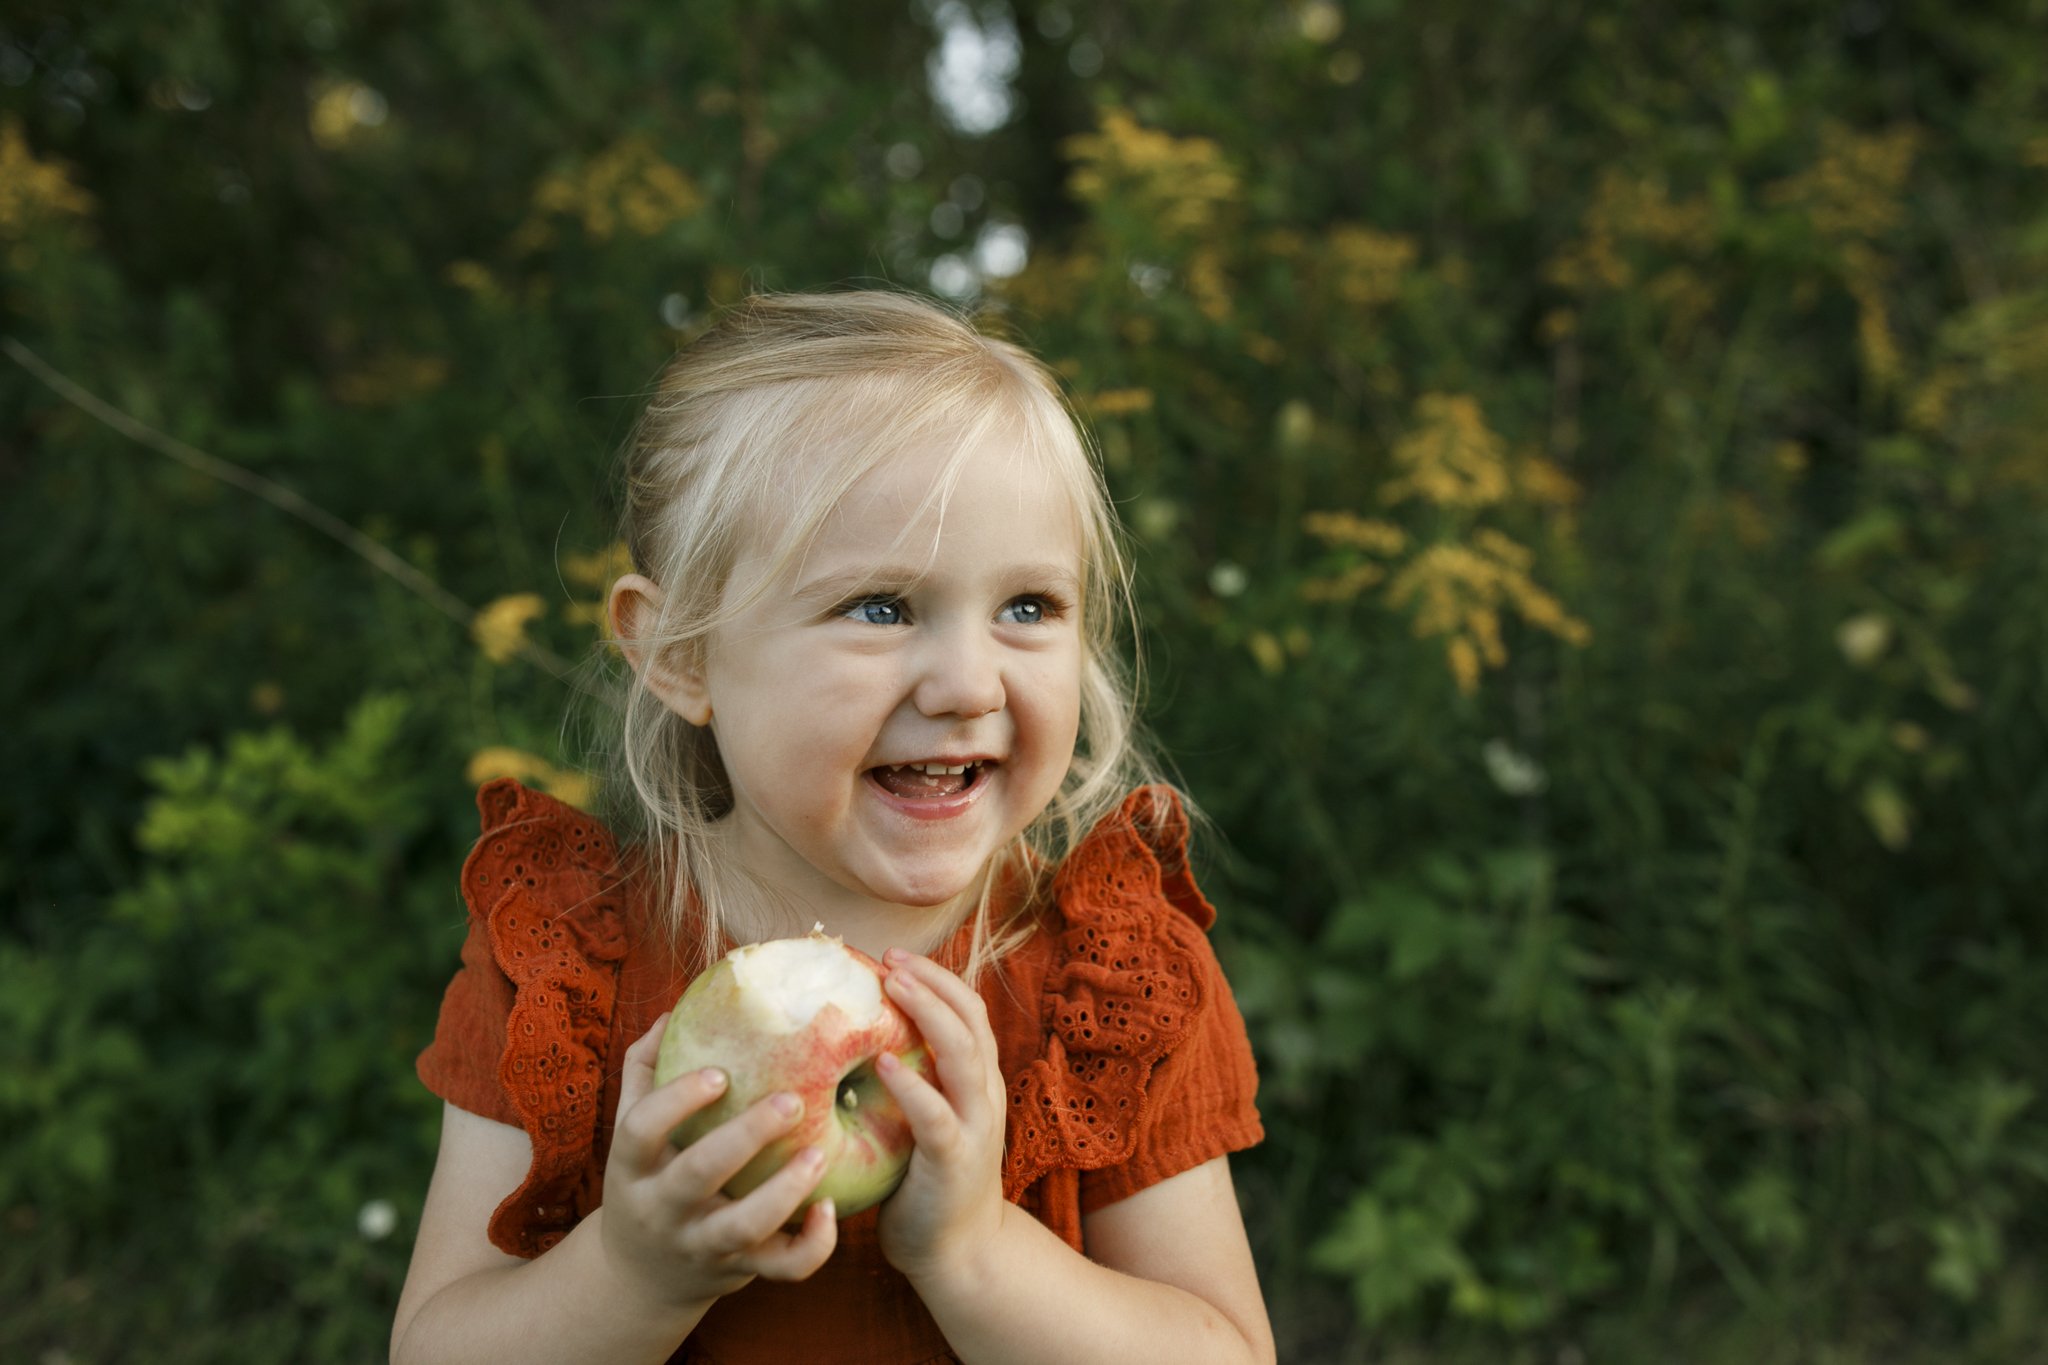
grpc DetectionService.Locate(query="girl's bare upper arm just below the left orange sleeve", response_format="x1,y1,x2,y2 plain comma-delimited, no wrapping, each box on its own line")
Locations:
391,1105,532,1342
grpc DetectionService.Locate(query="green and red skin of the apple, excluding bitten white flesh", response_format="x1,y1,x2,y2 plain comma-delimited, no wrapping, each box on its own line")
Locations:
653,945,932,1220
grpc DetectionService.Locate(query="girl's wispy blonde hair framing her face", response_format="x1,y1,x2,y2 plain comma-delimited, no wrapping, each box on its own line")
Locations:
585,291,1159,978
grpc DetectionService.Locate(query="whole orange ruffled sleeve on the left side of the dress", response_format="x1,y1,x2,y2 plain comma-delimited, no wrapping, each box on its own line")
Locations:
418,778,627,1257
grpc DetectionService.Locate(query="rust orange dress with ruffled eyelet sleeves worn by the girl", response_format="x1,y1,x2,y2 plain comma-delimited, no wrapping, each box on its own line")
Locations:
418,778,1264,1365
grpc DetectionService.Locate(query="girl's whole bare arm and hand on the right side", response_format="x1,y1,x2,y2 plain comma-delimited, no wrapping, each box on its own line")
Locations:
881,950,1274,1365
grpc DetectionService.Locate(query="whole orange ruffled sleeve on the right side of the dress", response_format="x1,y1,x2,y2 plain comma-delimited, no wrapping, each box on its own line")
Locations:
1004,788,1264,1219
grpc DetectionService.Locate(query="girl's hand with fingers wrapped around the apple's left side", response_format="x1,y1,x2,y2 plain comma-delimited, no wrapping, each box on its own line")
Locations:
598,1015,840,1308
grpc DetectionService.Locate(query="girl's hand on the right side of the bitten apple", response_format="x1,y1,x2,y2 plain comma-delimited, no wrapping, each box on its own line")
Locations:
877,948,1004,1283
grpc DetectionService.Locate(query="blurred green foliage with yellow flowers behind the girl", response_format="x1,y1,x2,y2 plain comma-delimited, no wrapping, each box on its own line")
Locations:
0,0,2048,1363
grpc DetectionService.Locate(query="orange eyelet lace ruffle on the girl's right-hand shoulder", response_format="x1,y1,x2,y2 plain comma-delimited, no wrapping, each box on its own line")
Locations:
1004,788,1217,1203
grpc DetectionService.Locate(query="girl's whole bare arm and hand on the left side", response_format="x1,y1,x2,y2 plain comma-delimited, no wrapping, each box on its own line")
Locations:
391,1015,838,1365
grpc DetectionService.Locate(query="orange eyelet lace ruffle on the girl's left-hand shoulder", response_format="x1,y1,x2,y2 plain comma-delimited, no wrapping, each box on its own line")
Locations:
463,778,627,1257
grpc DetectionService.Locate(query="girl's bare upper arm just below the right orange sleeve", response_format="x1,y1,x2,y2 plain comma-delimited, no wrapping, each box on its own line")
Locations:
1081,1156,1274,1361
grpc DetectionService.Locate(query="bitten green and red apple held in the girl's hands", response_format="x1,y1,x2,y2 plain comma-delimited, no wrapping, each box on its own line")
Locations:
653,929,932,1218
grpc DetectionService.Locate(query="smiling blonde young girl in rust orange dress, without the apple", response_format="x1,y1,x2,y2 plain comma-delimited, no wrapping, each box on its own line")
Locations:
391,293,1274,1365
